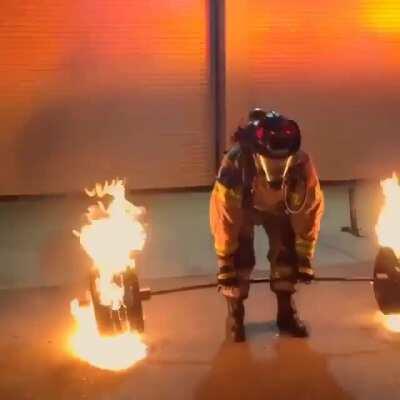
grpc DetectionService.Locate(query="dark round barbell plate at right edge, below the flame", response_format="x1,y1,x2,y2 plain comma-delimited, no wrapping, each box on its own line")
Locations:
373,247,400,314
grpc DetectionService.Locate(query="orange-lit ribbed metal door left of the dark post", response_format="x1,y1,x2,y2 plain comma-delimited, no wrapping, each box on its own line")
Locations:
0,0,215,194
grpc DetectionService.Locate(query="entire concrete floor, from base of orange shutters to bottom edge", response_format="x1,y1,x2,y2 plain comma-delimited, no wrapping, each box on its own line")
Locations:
0,182,400,400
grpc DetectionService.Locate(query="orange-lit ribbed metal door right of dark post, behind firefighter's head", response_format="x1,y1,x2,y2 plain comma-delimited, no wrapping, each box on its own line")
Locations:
226,0,400,180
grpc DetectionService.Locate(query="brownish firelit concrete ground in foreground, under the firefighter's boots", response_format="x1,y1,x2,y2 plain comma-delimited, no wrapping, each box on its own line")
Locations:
0,271,400,400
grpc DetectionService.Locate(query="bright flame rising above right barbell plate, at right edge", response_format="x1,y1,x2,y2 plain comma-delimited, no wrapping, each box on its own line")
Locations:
375,173,400,257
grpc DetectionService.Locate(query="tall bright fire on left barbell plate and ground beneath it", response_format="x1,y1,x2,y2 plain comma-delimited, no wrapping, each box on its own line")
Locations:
70,180,147,371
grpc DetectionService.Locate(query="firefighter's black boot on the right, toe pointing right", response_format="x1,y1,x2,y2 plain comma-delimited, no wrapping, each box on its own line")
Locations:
276,292,309,337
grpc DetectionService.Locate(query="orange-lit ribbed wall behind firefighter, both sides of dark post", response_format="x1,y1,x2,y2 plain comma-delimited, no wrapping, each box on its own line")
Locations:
0,0,400,195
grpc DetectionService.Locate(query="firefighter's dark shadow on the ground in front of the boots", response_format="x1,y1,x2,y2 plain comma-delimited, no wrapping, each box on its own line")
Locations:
195,338,352,400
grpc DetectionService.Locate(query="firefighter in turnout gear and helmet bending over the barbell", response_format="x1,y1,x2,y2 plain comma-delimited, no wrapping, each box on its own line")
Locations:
210,109,324,342
